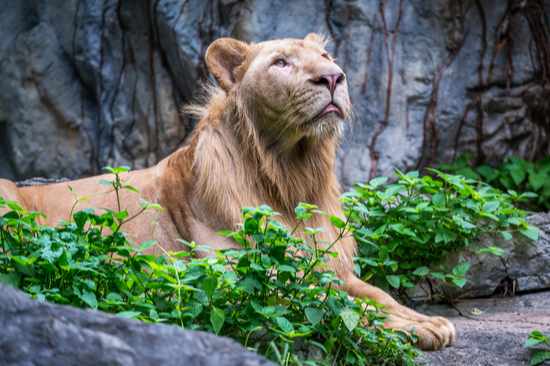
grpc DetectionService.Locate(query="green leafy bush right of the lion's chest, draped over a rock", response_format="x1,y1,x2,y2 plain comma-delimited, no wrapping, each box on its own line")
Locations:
342,169,538,290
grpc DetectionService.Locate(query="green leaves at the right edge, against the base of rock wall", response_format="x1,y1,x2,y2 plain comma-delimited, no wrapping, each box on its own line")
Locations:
439,153,550,211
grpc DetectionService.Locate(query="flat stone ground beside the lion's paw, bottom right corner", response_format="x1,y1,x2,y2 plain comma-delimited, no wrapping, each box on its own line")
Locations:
417,292,550,366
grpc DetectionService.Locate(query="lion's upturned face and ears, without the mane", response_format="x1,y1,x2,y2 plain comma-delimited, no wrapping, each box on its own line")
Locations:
206,33,350,142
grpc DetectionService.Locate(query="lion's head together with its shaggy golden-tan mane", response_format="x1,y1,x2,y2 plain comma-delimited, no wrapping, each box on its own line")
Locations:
185,34,355,274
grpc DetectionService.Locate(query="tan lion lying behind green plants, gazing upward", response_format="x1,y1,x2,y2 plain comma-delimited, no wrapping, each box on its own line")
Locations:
0,33,456,350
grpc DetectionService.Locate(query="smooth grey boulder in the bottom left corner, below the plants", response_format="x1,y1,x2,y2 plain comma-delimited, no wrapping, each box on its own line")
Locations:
0,283,273,366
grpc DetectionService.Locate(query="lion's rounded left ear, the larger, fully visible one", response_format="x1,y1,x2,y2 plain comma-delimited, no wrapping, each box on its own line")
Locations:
205,38,250,92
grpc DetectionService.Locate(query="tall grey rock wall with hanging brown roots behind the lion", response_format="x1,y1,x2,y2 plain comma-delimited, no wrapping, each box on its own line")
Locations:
0,0,550,185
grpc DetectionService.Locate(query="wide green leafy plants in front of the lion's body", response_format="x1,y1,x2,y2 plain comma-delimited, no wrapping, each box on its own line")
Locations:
0,167,421,365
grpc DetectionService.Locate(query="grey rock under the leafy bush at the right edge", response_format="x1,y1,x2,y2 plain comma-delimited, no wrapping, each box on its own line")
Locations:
408,212,550,300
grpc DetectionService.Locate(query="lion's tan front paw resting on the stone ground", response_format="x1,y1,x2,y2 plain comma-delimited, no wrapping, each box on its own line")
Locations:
408,317,456,351
